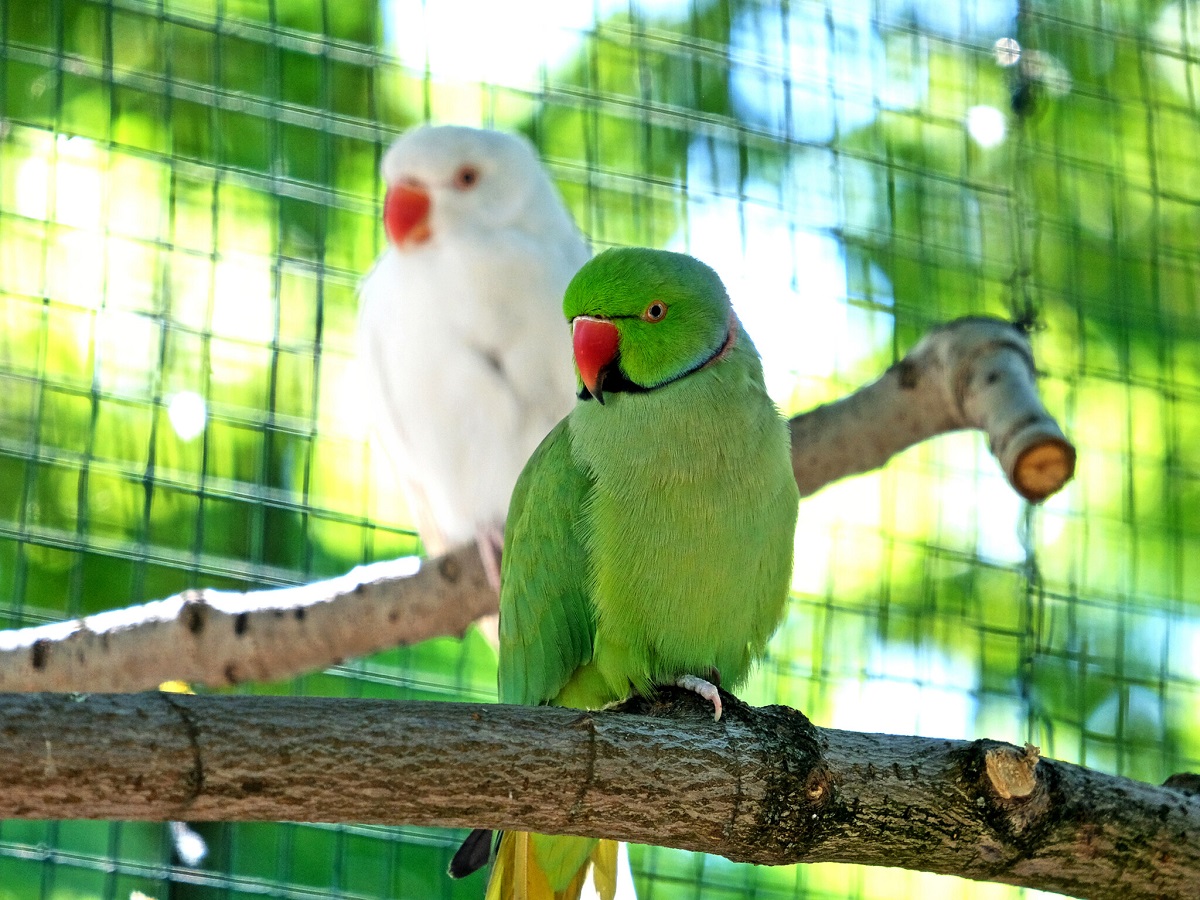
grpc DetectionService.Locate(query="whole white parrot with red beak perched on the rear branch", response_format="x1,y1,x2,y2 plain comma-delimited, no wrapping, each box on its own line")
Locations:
358,126,590,587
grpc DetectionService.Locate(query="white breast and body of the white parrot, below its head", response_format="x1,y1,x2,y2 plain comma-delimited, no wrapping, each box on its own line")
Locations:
359,226,586,544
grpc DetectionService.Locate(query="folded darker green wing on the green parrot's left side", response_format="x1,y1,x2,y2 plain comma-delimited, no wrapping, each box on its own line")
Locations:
500,419,595,704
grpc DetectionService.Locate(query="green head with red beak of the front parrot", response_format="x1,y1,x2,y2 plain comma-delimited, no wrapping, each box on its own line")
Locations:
563,247,737,403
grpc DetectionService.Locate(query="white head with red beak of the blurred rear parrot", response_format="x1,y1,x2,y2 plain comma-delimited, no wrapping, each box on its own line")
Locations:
382,125,547,250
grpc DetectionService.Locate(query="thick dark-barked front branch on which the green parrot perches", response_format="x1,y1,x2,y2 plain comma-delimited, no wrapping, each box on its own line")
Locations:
0,690,1200,898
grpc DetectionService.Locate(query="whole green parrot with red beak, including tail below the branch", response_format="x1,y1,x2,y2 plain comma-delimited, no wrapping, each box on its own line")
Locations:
450,248,799,900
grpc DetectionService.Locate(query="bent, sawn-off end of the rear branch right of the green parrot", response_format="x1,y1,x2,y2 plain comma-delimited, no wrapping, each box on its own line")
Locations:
792,318,1075,503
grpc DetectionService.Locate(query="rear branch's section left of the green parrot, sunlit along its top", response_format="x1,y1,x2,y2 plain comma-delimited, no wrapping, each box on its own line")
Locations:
0,554,498,691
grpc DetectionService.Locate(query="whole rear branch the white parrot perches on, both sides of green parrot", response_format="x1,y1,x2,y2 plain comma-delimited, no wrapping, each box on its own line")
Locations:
0,318,1075,691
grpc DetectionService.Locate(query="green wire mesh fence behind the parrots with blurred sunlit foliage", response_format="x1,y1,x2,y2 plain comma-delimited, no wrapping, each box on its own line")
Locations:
0,0,1200,900
